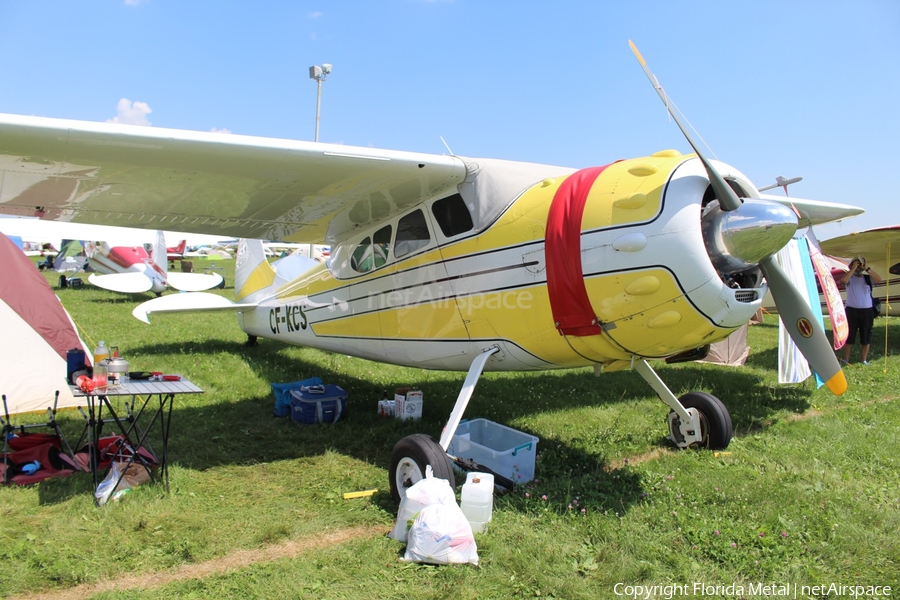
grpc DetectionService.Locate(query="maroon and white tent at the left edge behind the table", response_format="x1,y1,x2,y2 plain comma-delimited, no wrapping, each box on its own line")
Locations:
0,234,91,414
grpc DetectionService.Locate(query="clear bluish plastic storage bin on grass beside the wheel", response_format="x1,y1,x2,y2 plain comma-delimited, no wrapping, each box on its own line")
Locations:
447,419,538,483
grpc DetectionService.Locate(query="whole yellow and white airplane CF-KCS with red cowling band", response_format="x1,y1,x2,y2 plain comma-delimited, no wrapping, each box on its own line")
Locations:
0,46,862,498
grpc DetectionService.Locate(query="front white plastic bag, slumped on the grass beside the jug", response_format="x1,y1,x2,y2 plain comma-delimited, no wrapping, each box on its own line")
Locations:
403,500,478,565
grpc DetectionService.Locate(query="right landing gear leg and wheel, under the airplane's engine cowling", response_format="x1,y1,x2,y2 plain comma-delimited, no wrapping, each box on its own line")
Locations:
634,359,733,450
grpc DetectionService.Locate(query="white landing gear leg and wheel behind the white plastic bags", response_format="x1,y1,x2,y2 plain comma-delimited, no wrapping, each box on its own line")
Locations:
390,346,500,502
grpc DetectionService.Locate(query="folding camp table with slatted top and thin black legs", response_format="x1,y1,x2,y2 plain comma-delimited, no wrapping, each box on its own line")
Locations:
72,378,203,502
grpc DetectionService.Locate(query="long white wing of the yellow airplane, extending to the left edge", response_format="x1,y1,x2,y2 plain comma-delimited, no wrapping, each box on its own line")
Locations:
0,114,466,243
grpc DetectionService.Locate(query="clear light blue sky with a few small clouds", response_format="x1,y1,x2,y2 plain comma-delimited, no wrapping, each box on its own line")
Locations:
0,0,900,239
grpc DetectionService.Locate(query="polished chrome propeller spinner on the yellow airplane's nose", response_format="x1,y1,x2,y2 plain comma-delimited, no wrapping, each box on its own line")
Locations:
703,199,798,273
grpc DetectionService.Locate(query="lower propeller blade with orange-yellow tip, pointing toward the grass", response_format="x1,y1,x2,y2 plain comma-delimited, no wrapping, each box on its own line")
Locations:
759,256,847,396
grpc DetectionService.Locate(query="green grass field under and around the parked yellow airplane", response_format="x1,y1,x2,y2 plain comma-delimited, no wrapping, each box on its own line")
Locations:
0,263,900,599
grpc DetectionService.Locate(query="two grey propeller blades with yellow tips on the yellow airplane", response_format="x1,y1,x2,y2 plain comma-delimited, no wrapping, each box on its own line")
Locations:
628,40,847,396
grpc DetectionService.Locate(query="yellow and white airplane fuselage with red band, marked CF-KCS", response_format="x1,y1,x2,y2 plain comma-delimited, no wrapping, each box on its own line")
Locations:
232,152,765,370
